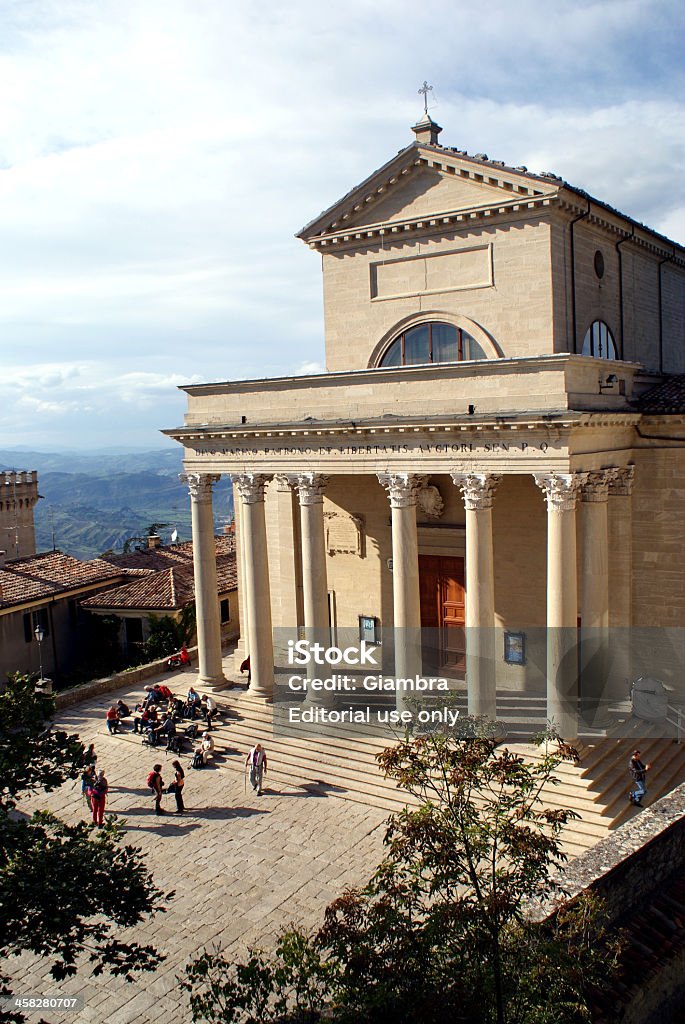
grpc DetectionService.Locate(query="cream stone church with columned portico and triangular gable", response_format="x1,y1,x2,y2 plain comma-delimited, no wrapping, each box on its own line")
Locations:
165,115,685,736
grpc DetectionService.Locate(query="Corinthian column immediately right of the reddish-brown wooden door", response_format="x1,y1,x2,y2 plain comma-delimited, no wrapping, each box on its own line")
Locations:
452,473,502,720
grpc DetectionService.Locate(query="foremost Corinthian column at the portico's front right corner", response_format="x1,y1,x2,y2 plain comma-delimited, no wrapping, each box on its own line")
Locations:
534,473,587,740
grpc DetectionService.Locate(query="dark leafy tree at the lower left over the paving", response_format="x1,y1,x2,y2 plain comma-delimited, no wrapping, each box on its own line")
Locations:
0,676,172,1021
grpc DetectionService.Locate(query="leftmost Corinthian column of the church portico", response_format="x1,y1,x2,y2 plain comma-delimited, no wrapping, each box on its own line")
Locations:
181,473,226,687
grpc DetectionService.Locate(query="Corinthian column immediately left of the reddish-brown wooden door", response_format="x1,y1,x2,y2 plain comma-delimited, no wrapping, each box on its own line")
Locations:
378,473,428,678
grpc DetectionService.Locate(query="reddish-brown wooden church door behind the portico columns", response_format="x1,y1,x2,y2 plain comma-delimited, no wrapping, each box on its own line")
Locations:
419,555,466,677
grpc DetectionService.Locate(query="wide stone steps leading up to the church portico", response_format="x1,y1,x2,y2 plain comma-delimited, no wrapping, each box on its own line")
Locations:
210,692,685,857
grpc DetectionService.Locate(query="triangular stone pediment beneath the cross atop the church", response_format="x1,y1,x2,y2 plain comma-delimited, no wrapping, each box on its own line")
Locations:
299,143,563,242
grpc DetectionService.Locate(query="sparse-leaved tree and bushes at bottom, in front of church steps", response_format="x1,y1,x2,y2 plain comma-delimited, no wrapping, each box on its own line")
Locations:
184,730,616,1024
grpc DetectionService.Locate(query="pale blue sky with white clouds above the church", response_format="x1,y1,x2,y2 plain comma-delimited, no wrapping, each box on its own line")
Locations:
0,0,685,451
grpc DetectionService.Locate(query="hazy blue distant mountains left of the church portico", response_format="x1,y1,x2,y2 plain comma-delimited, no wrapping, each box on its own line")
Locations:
0,447,233,558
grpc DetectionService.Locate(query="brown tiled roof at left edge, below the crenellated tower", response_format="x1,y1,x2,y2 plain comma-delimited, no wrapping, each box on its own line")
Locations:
0,551,123,608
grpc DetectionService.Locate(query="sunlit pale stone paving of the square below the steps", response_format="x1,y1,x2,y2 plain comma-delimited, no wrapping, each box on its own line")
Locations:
6,659,387,1024
